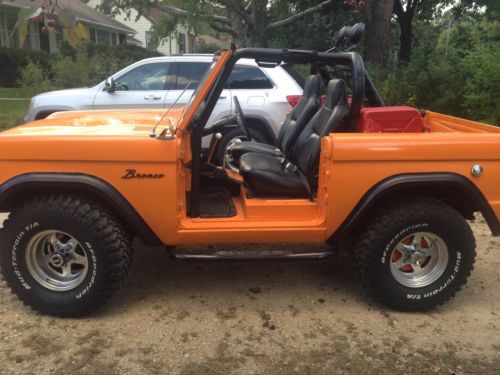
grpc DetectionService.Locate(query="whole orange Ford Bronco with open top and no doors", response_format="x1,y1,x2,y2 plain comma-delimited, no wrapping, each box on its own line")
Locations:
0,49,500,316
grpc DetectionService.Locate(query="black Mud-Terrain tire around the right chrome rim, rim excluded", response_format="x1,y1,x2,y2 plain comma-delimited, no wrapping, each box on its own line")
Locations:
354,197,476,311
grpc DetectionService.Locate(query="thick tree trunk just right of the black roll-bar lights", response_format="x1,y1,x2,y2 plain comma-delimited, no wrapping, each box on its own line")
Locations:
364,0,394,67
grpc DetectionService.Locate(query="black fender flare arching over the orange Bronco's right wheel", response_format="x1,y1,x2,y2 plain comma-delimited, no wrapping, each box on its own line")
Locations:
329,173,500,242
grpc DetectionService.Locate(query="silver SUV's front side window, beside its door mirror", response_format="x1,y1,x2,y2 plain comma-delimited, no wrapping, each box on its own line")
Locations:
115,63,170,91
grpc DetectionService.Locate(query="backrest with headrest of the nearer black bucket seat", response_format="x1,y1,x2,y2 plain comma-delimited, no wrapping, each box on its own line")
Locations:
289,79,349,179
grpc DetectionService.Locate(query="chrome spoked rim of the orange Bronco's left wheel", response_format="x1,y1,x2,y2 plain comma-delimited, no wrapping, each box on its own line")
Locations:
26,230,89,292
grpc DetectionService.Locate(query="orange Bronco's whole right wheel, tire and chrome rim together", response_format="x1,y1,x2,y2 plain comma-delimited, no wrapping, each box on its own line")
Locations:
355,198,476,311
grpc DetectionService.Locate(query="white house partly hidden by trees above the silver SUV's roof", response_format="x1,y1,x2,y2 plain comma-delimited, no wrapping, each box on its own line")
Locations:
86,0,196,55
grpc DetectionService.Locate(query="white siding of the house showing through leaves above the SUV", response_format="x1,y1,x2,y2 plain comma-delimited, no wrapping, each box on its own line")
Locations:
87,0,192,55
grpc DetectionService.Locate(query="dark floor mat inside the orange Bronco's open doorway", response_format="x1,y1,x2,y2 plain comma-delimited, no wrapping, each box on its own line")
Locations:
187,187,236,218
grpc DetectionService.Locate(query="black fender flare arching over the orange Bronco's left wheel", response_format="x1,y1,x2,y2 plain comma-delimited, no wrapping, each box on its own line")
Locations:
0,173,162,246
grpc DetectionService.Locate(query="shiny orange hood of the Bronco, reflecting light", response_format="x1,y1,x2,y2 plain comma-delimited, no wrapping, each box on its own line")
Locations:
0,108,183,137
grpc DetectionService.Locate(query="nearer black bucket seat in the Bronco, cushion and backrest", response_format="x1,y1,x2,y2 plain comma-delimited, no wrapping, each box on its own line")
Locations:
240,79,349,198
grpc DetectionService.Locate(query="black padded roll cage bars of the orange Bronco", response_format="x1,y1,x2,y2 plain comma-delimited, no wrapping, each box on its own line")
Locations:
189,48,376,217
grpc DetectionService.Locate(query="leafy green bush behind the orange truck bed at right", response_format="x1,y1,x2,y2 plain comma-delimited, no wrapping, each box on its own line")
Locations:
369,20,500,125
